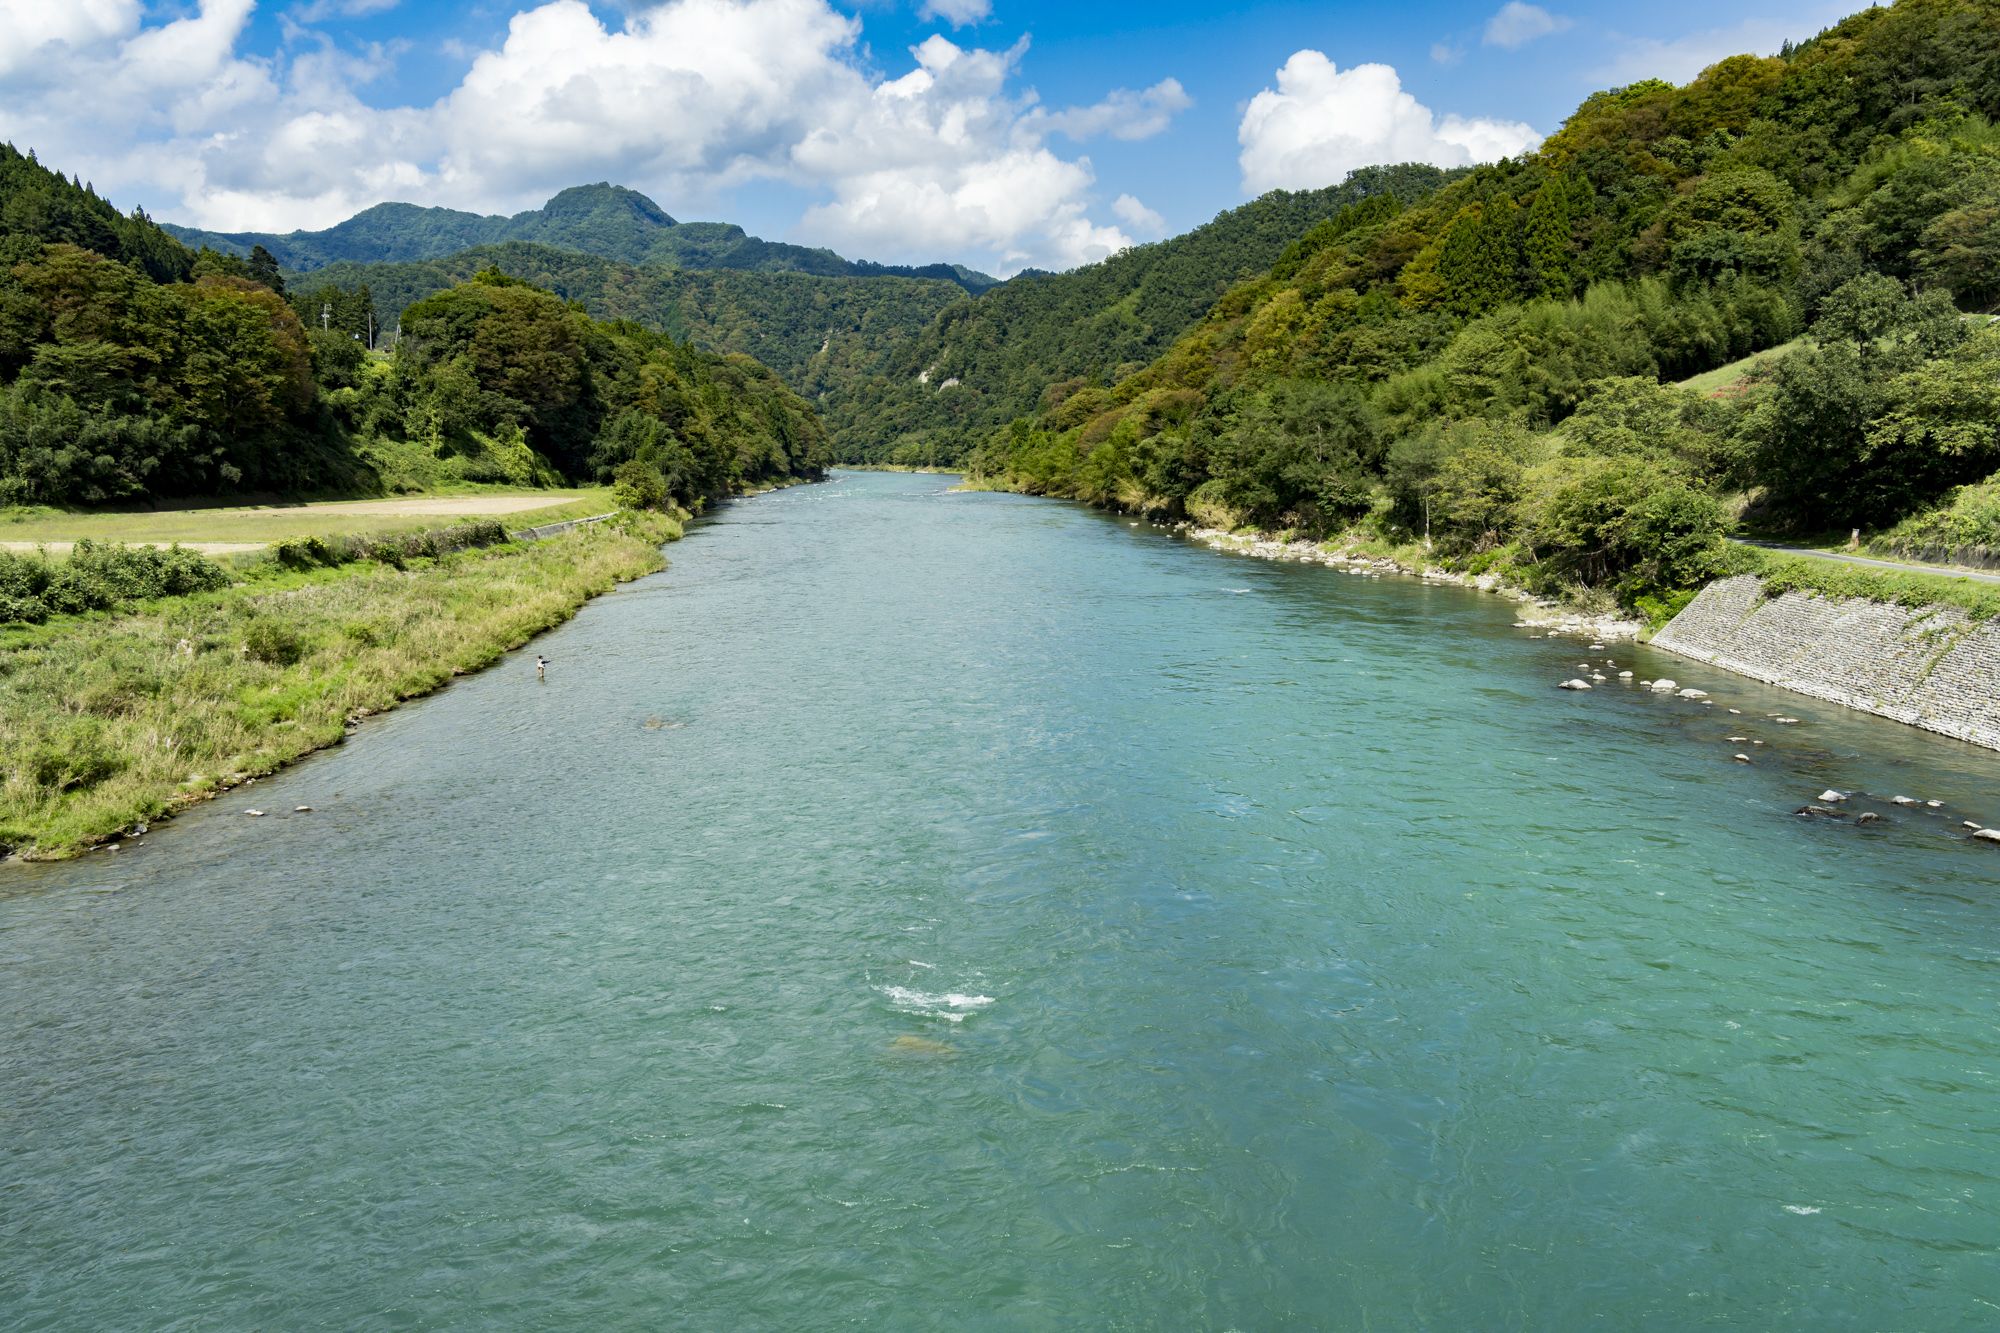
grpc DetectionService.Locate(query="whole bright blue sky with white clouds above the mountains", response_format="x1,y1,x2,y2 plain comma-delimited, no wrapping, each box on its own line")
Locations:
0,0,1856,272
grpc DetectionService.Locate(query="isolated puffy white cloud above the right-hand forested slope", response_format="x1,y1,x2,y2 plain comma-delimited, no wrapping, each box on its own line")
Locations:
1236,50,1542,194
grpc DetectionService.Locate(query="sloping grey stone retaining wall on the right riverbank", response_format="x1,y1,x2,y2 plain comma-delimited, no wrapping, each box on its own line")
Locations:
1652,574,2000,751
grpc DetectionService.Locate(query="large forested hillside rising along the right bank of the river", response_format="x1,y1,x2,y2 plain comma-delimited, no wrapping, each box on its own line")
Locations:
976,0,2000,604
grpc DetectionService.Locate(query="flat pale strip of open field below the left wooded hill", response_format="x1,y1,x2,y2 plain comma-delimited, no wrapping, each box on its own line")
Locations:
0,486,618,544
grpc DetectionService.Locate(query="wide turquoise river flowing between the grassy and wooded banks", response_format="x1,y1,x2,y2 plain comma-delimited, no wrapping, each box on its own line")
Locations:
0,474,2000,1329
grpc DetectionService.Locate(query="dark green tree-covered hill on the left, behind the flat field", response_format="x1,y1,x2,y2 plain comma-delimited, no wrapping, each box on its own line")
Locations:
0,148,826,504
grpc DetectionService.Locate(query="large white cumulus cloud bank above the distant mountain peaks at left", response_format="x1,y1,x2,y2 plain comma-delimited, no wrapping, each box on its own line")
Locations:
0,0,1188,270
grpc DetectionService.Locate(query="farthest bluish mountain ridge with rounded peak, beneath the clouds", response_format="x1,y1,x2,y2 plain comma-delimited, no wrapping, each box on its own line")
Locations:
166,184,994,292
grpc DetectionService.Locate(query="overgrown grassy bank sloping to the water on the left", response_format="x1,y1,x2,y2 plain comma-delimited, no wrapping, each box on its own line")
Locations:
0,514,680,859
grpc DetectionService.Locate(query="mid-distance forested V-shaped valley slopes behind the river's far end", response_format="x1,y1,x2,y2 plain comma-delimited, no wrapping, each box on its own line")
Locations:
294,166,1450,464
